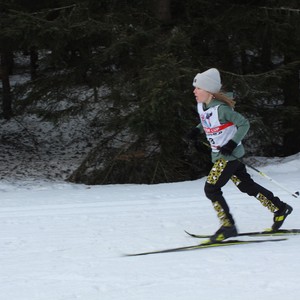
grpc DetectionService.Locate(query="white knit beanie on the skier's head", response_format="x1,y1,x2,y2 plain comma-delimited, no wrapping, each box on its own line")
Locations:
193,68,222,94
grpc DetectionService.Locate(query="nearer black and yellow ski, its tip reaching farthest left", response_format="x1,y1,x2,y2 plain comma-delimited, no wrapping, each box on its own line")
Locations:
125,238,287,256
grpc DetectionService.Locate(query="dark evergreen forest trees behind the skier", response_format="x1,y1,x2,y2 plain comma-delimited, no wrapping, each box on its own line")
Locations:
0,0,300,184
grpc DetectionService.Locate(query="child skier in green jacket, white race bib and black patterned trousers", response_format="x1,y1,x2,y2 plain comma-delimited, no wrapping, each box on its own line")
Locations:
188,68,293,242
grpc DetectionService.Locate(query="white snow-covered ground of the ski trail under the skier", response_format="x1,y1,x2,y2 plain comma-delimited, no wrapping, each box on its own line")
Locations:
0,153,300,300
